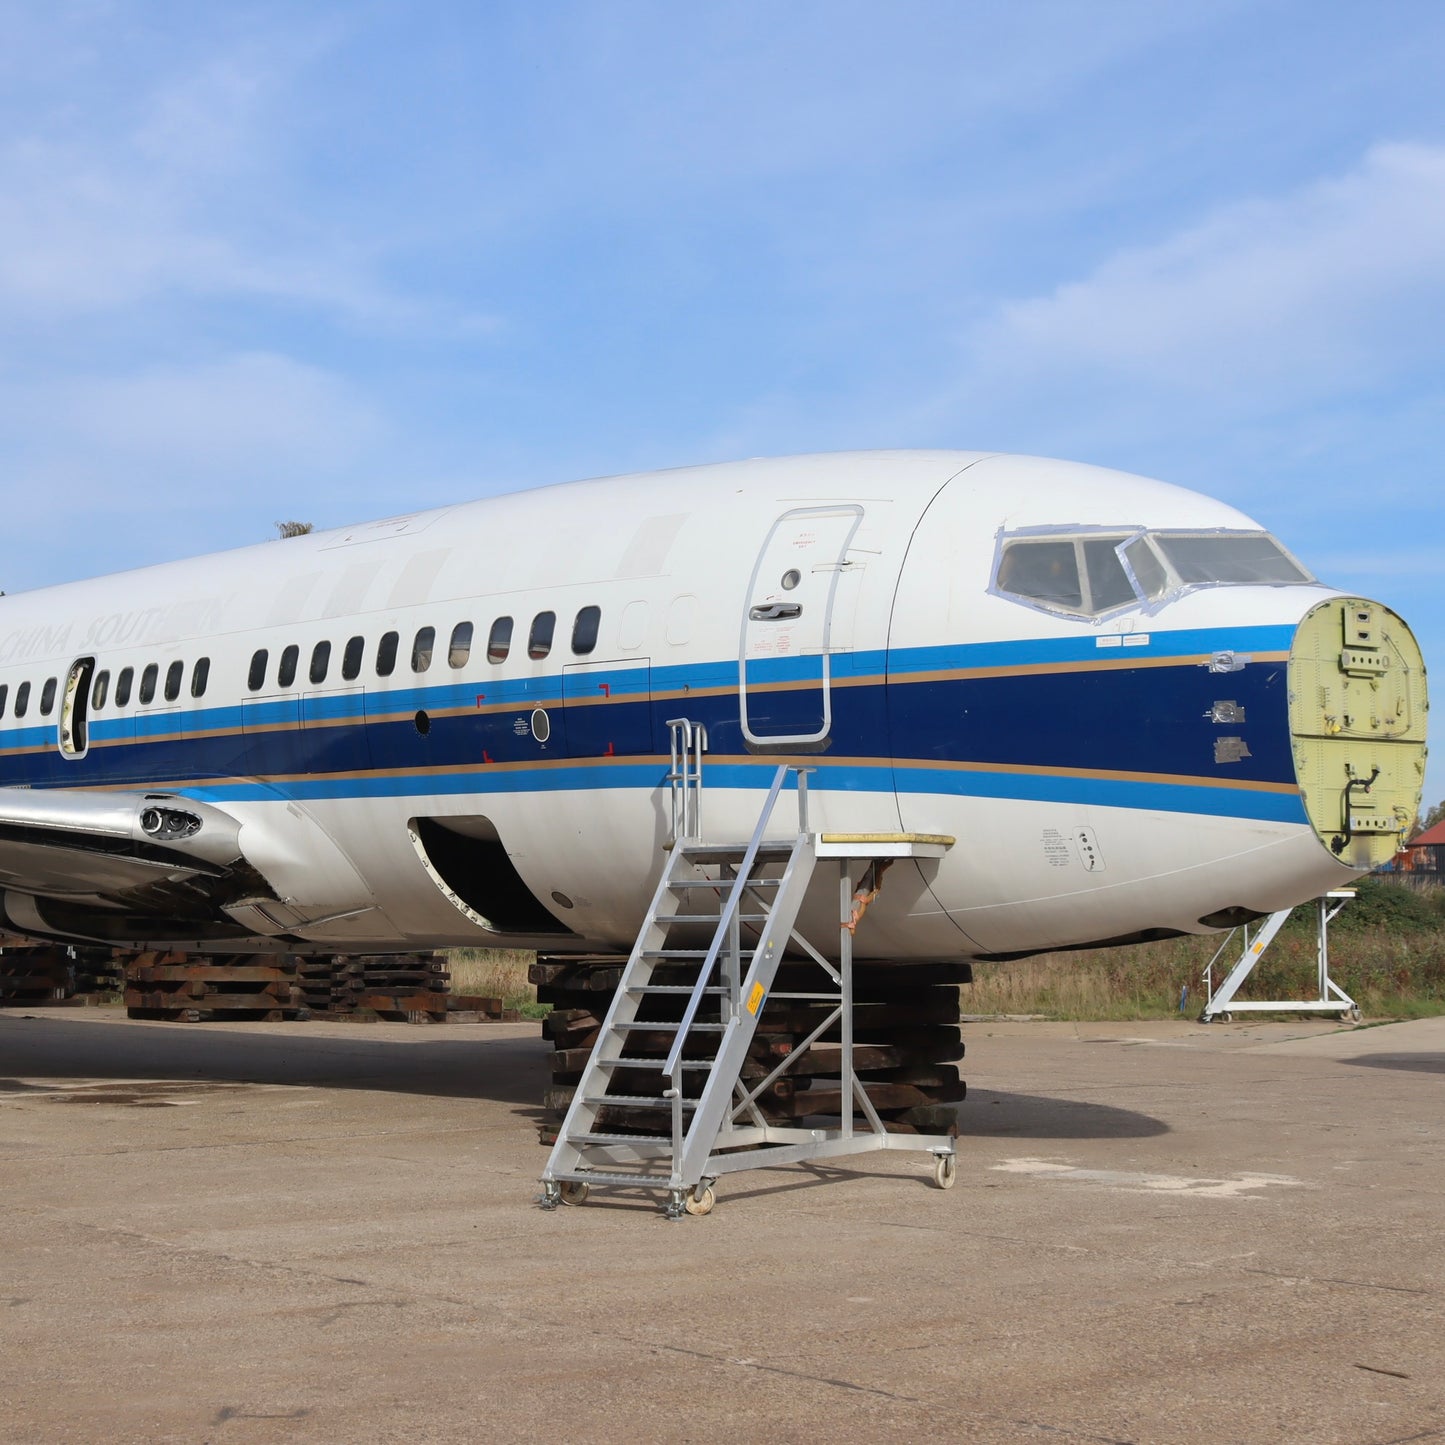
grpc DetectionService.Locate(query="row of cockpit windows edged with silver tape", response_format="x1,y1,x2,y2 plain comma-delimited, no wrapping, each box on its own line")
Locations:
990,529,1314,617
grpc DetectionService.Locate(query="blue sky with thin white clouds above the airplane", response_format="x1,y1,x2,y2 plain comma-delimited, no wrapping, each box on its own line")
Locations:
0,0,1445,801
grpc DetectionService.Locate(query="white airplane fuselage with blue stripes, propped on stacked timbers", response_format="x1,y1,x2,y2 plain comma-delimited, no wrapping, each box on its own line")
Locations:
0,452,1426,958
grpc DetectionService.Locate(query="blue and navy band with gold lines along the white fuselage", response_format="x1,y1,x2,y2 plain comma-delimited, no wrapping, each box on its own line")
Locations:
0,626,1303,821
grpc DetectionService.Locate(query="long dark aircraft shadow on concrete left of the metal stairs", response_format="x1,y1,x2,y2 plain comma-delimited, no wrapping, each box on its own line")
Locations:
0,1014,551,1116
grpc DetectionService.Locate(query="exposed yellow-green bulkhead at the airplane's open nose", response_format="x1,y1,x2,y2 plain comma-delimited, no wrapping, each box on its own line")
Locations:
1289,597,1429,871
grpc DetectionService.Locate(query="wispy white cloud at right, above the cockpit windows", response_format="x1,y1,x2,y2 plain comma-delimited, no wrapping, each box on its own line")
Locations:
952,145,1445,425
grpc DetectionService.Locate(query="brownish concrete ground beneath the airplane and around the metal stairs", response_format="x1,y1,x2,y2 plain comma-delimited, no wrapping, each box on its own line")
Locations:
0,1010,1445,1445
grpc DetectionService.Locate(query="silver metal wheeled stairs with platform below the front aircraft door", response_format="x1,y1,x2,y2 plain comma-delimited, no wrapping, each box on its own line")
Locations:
539,757,955,1218
